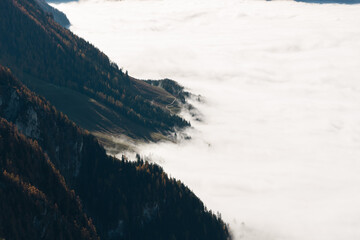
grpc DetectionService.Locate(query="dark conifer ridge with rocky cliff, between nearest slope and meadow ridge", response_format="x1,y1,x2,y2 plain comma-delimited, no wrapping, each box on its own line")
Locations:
0,67,229,240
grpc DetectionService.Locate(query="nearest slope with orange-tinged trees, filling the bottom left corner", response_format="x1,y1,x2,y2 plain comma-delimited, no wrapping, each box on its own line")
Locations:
0,118,98,239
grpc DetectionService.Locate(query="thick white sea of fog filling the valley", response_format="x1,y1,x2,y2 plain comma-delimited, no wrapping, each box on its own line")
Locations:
53,0,360,240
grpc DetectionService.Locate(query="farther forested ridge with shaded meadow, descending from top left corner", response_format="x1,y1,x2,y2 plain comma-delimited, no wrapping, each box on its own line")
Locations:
0,0,190,141
